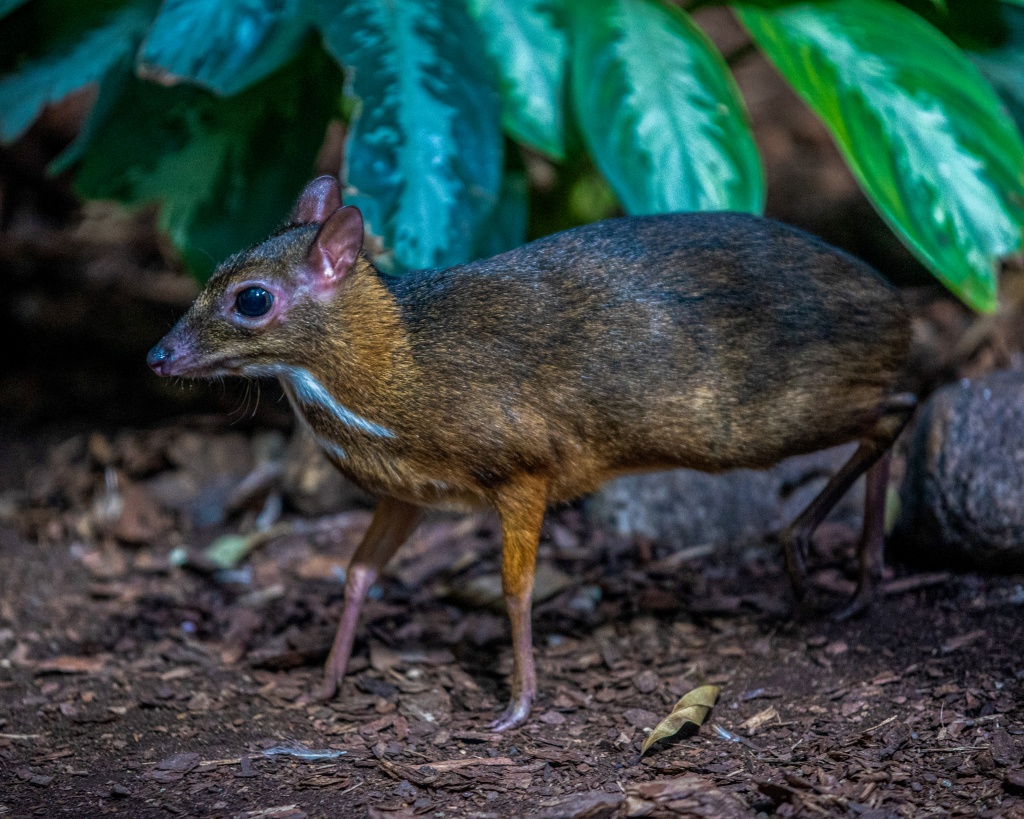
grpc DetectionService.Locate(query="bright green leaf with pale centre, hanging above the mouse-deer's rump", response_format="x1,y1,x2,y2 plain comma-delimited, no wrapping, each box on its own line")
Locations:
736,0,1024,310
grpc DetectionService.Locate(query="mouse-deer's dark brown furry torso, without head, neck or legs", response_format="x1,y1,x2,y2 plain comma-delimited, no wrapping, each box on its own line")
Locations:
360,214,909,498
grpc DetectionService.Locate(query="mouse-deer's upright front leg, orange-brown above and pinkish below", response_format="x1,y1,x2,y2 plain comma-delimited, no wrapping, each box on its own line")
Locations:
490,476,548,731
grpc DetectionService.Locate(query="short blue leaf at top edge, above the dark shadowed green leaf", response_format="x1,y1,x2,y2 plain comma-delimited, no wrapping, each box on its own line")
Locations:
139,0,308,95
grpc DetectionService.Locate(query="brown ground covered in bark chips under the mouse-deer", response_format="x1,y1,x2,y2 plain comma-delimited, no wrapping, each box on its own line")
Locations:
0,422,1024,817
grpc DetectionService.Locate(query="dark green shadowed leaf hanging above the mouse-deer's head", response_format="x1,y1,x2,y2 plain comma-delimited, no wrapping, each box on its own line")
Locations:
77,41,341,274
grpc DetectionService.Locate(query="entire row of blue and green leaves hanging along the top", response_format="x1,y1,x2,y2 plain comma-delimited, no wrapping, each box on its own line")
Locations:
0,0,1024,310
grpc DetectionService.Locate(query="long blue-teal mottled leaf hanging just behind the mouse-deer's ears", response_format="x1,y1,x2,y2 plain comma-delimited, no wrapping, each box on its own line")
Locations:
321,0,504,268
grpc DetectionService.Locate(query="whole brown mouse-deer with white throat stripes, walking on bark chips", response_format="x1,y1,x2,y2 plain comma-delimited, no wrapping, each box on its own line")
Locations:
151,178,913,728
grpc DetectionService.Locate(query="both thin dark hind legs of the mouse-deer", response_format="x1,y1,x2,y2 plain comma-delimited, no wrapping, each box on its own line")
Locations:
779,393,916,599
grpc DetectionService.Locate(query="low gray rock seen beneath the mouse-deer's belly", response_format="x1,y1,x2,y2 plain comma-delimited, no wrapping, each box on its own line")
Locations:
588,443,863,549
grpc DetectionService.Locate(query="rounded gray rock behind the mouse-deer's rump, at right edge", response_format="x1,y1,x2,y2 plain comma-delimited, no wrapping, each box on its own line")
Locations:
893,371,1024,571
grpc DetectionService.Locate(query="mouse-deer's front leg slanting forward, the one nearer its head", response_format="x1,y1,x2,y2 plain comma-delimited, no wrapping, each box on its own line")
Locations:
316,498,423,699
